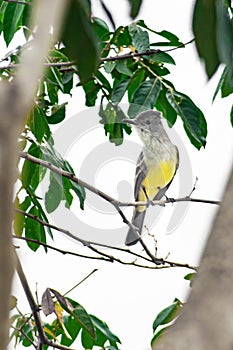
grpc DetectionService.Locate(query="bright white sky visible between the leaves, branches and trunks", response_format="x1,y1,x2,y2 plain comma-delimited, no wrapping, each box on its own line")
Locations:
7,0,233,350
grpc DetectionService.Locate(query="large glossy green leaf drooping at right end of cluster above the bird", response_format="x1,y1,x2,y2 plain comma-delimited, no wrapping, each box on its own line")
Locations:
166,90,207,149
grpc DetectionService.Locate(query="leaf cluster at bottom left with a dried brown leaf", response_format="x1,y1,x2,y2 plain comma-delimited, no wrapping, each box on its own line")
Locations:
11,289,121,350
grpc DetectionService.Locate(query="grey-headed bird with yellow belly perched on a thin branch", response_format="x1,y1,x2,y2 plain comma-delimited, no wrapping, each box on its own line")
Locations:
123,111,179,245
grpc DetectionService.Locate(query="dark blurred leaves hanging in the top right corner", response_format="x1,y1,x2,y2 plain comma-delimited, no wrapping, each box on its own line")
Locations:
193,0,233,119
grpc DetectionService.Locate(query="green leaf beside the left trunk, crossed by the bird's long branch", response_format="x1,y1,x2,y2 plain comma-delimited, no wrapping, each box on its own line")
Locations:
21,144,41,188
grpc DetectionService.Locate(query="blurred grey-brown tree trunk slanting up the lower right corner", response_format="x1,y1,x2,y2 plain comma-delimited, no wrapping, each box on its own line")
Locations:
153,164,233,350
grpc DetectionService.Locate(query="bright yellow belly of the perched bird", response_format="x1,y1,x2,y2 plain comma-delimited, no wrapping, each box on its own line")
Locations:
138,159,176,211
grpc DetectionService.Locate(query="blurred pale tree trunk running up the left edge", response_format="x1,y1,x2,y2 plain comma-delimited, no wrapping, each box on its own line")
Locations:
0,0,66,350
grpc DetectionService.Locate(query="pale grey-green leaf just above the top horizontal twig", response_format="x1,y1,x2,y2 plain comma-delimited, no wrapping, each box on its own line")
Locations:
128,23,150,52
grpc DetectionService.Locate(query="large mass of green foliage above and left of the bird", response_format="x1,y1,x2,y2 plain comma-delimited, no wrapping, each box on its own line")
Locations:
0,0,207,258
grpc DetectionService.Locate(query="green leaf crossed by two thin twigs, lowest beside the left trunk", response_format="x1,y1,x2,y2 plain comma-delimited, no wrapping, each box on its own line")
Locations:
25,207,41,252
